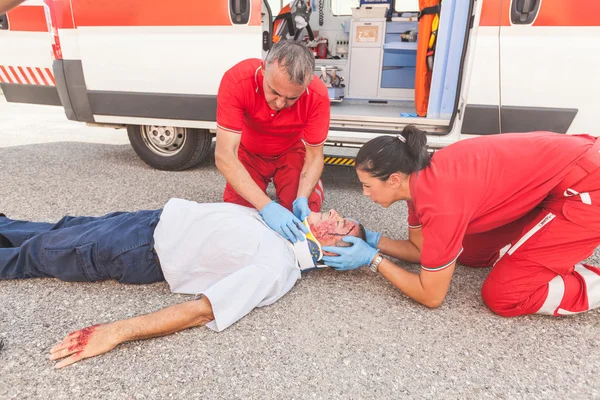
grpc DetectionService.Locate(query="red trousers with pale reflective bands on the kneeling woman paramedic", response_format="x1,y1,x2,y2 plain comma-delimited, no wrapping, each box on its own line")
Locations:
458,145,600,317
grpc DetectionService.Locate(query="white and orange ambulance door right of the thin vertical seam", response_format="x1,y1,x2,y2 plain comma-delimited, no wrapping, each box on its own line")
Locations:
496,0,600,134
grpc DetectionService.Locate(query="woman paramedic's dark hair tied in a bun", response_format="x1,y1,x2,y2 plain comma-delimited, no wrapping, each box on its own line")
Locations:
355,125,431,181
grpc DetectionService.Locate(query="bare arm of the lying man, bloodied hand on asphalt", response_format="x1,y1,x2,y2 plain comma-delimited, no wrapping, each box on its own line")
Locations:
49,297,215,368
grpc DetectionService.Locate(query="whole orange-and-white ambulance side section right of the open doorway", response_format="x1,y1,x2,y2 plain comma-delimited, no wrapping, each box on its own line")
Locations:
462,0,600,135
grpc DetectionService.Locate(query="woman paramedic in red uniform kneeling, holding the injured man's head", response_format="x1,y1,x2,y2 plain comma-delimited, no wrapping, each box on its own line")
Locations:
323,126,600,316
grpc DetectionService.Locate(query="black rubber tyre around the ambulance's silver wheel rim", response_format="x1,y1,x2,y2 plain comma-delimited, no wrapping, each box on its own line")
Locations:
127,125,214,171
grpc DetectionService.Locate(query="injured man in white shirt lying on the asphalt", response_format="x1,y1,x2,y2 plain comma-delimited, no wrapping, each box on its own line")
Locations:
0,199,365,368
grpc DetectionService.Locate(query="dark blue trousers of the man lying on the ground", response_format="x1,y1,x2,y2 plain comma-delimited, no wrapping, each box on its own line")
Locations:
0,210,164,284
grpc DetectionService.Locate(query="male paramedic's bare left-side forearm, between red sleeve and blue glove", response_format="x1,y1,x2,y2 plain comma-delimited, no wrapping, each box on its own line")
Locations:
215,128,271,210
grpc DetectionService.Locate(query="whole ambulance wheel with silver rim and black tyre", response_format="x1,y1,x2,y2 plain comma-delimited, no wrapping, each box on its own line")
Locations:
127,125,213,171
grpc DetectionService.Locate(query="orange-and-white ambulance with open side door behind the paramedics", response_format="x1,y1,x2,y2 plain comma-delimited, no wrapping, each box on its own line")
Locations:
0,0,600,170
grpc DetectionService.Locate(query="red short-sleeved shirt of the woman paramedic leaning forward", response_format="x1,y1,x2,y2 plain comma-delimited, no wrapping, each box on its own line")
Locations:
408,132,595,271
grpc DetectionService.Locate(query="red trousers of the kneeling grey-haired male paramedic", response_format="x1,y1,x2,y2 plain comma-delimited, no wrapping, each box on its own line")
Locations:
223,141,324,212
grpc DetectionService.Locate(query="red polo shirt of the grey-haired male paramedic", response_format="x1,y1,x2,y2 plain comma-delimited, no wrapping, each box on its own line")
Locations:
217,59,330,157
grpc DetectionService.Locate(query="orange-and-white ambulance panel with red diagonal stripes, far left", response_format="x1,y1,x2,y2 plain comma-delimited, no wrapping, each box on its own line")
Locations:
0,0,61,106
